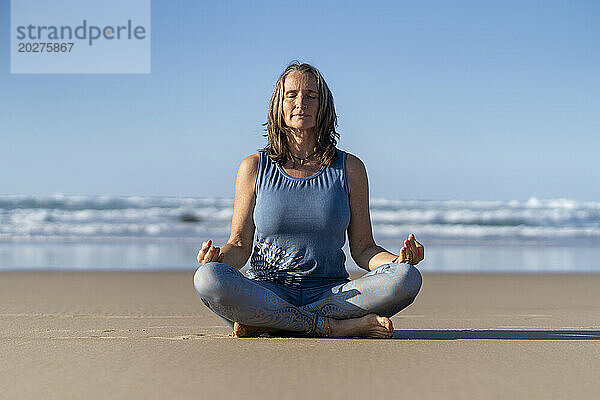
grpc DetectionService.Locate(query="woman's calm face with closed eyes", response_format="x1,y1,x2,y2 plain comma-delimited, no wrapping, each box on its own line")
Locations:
283,71,319,130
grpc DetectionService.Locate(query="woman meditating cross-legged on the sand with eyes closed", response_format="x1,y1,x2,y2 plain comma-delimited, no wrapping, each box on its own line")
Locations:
194,62,424,338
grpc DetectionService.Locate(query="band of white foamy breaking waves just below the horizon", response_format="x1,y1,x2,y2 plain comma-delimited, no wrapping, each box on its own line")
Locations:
0,195,600,241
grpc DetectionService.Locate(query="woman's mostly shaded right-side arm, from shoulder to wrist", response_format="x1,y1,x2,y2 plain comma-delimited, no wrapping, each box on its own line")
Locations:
346,154,398,271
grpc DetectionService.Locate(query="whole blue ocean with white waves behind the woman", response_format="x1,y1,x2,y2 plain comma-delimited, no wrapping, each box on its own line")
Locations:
0,195,600,272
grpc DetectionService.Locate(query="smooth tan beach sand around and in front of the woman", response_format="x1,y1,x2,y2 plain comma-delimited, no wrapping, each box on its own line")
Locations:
0,271,600,400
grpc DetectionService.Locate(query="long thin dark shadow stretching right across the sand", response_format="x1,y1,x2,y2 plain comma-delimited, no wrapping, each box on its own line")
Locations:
393,329,600,340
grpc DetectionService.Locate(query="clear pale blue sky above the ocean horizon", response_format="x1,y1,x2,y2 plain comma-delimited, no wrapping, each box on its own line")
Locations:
0,0,600,200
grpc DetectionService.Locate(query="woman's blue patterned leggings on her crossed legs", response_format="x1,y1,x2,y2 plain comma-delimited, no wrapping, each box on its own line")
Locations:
194,262,422,336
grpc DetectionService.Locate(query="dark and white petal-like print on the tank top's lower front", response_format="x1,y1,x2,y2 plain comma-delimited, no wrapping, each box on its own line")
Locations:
252,236,304,275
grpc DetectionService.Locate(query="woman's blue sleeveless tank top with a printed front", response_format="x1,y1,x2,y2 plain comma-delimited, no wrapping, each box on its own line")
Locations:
246,149,350,287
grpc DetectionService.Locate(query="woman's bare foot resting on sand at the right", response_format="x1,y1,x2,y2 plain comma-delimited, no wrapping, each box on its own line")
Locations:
325,314,394,339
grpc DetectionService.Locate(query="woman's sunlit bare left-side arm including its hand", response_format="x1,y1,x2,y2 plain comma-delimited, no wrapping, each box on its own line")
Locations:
198,154,258,270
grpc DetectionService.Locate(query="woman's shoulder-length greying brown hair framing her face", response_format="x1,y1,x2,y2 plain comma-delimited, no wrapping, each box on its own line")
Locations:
263,61,340,167
